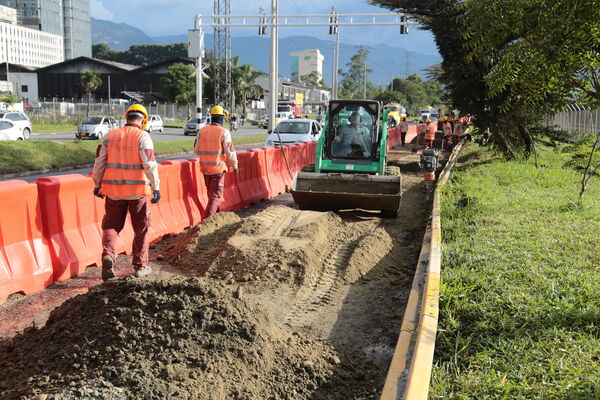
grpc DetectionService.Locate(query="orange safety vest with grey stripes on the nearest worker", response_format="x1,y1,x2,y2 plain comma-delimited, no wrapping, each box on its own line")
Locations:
100,125,152,197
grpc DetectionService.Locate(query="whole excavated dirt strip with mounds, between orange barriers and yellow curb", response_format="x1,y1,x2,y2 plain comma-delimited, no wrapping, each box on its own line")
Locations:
0,151,430,400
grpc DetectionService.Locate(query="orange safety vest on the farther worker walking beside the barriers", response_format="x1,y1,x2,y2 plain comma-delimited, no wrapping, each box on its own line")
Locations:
194,124,227,175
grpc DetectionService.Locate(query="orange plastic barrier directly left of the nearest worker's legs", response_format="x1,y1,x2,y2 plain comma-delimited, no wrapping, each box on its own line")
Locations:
36,174,102,282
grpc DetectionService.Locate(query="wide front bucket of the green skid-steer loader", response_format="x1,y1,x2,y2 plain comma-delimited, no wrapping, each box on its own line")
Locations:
291,172,402,216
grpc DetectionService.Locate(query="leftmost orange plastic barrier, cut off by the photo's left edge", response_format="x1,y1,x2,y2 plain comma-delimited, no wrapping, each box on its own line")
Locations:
0,181,53,304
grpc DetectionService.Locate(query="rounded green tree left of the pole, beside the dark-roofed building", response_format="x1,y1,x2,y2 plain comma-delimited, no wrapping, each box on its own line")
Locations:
160,63,196,117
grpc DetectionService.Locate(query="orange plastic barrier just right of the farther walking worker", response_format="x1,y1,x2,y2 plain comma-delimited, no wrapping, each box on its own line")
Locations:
237,149,269,206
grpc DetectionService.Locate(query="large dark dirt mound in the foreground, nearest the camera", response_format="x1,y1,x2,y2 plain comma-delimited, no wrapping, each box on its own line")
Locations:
0,278,381,400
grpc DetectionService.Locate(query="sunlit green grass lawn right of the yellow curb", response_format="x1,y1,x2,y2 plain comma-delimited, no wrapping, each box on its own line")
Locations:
429,145,600,400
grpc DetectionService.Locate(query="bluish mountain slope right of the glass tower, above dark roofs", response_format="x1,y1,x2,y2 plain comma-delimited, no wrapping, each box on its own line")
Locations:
92,18,155,51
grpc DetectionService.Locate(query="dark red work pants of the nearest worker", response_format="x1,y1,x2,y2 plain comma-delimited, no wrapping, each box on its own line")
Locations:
102,197,150,266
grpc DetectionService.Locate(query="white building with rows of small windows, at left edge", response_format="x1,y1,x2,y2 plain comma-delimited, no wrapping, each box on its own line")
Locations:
0,22,64,67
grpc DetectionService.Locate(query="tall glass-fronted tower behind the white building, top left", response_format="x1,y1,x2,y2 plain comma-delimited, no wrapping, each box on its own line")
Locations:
0,0,92,59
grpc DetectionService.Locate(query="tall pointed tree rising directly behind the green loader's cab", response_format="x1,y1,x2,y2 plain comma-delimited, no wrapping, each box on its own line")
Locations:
340,46,378,99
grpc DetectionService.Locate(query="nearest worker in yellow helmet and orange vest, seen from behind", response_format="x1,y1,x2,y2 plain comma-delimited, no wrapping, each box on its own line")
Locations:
92,104,160,281
